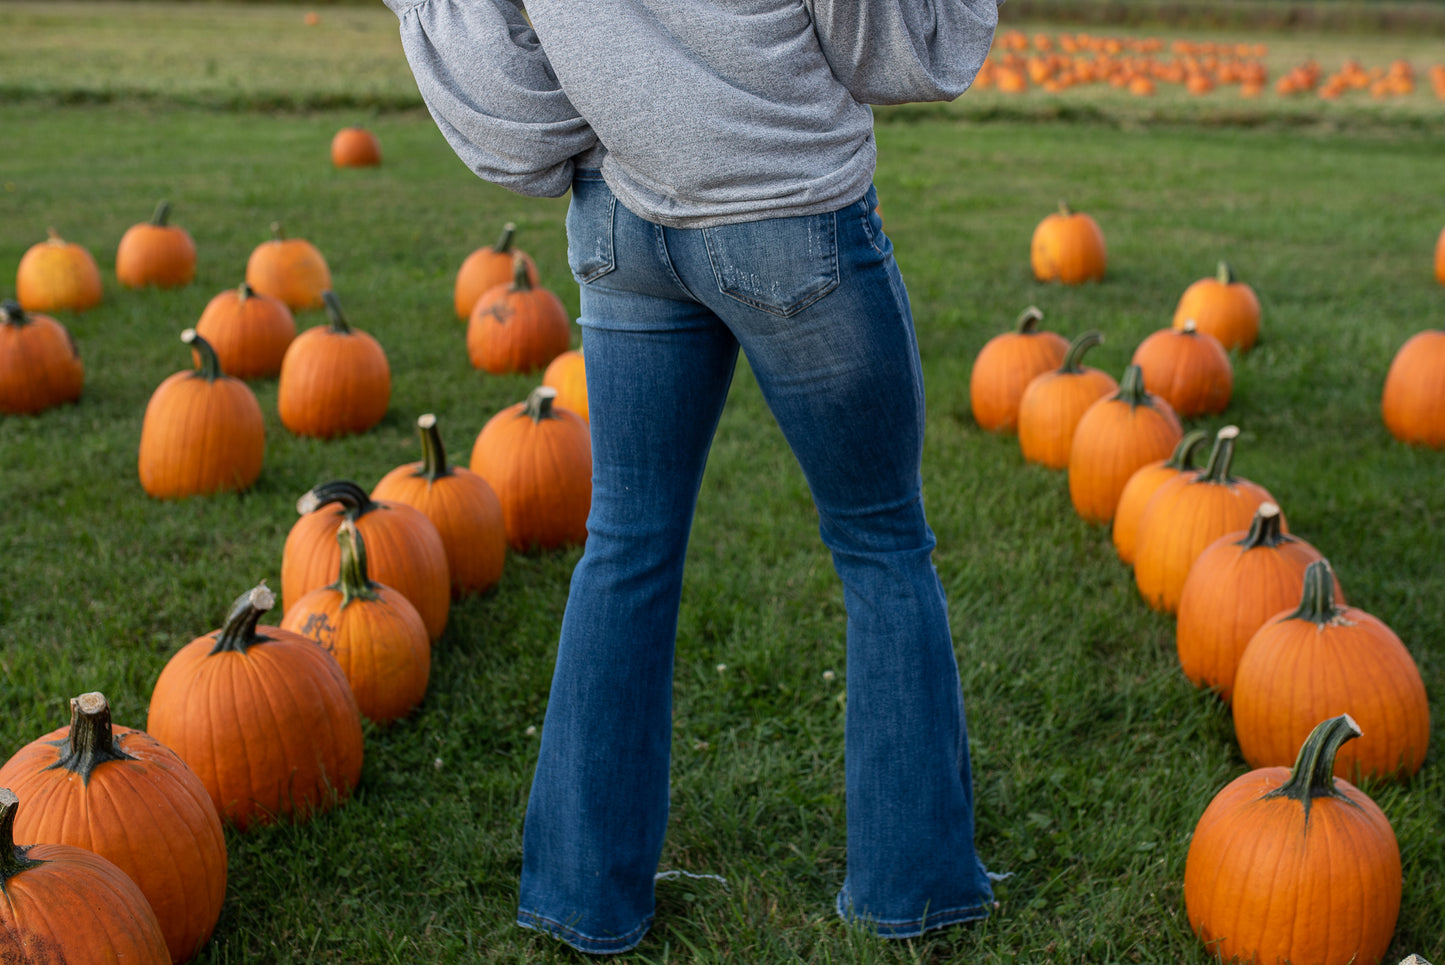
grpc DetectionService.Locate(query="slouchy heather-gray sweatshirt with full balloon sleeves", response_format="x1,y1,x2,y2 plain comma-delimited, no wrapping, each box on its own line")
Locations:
386,0,1000,227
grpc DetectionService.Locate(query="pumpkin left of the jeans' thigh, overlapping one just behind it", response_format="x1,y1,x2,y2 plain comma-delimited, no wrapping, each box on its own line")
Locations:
467,259,572,376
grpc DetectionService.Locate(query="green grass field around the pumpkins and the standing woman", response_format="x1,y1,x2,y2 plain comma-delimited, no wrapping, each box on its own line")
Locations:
8,3,1445,965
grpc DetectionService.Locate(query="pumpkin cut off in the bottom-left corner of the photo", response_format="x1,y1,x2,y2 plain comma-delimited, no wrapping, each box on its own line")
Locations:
0,787,171,965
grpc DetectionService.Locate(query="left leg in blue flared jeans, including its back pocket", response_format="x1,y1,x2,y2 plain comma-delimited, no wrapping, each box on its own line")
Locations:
517,171,737,953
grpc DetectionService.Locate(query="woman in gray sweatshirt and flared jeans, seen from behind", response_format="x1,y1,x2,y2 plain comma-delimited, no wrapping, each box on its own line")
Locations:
387,0,997,953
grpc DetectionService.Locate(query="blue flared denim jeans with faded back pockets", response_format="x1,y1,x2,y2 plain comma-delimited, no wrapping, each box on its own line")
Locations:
517,170,993,953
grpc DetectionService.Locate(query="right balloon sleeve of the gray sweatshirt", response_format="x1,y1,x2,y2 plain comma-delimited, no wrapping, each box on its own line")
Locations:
806,0,1001,104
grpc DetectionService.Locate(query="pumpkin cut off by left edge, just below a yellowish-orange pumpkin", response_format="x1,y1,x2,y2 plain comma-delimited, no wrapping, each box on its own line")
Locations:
0,299,85,415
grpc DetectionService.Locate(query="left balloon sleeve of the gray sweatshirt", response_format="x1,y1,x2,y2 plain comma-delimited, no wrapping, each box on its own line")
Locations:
384,0,597,198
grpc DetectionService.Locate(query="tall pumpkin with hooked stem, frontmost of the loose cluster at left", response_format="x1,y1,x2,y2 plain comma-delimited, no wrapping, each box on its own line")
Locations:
137,328,266,500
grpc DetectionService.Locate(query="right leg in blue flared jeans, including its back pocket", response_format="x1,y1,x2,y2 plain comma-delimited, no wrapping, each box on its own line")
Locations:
664,192,993,938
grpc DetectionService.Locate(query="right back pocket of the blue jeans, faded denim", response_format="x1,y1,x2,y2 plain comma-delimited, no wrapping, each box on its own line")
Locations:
702,212,838,318
